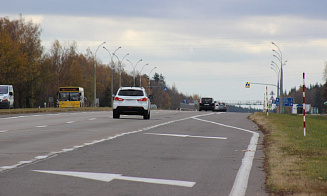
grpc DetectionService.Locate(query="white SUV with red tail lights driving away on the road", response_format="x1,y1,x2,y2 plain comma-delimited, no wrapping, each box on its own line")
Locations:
112,87,151,119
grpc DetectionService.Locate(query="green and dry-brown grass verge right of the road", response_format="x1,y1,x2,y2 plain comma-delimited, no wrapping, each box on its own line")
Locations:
250,113,327,195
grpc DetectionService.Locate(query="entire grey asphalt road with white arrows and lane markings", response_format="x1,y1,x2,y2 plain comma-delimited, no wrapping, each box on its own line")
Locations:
0,111,267,196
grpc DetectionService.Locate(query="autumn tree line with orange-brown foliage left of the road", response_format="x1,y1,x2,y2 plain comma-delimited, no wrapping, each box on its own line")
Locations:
0,15,193,109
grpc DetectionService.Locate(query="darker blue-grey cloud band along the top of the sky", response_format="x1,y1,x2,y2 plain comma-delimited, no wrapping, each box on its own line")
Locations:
0,0,327,19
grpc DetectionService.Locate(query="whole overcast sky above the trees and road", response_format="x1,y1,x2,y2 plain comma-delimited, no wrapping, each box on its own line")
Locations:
0,0,327,105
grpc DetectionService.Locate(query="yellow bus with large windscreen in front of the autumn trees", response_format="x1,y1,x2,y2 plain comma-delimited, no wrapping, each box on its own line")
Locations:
58,87,84,108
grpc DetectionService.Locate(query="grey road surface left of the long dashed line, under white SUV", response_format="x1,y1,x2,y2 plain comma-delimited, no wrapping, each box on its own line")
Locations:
0,111,193,168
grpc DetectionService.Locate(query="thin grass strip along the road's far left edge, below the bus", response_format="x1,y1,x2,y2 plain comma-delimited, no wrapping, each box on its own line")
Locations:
0,107,112,115
